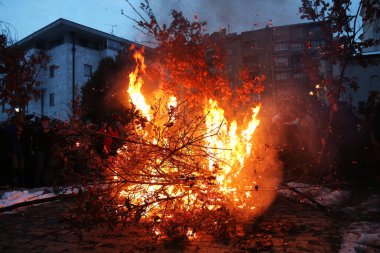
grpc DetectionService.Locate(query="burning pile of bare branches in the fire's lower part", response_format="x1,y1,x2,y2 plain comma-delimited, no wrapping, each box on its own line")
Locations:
62,101,236,242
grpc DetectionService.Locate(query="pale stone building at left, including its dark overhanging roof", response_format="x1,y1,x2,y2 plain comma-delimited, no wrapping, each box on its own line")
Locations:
0,19,140,120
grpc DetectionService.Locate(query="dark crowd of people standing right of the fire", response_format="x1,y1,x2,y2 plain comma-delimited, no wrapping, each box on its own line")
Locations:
272,99,380,184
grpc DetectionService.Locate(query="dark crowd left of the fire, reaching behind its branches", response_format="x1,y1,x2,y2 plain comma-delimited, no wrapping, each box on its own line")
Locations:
0,116,125,188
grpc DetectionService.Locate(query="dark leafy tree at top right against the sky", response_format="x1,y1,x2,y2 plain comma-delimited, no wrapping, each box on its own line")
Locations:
299,0,380,107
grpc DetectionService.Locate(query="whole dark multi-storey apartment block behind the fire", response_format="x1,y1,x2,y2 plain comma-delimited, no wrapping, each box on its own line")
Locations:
211,22,332,101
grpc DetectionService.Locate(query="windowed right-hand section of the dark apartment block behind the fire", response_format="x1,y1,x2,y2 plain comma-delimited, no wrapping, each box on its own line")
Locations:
273,23,329,100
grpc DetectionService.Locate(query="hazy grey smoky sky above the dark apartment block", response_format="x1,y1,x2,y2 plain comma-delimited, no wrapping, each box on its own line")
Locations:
147,0,301,33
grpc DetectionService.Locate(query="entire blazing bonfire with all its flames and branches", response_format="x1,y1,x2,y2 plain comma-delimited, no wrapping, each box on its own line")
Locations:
67,3,280,245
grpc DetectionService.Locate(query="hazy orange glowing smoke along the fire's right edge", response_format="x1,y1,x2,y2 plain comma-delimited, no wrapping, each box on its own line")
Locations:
232,101,283,223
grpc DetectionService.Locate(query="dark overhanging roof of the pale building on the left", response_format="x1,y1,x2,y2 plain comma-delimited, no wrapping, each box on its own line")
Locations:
16,18,134,48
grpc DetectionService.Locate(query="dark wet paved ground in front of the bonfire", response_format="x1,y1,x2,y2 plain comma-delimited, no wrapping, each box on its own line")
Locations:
0,193,342,253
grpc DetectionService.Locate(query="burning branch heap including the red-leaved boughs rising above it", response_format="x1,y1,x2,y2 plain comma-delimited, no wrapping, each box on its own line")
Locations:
60,1,264,245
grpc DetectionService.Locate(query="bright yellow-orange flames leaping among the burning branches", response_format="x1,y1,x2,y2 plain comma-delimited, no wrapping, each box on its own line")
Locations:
118,48,266,238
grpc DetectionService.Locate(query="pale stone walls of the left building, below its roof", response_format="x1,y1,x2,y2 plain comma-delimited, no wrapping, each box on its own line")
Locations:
0,34,117,120
